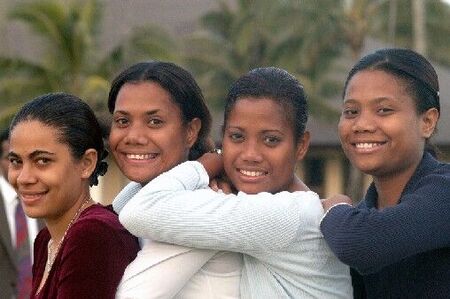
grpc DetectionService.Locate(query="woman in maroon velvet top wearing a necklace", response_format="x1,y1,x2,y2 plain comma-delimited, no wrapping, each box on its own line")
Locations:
8,93,139,298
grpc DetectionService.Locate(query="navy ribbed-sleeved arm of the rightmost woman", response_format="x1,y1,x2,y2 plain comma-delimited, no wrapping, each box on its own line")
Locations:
321,199,450,274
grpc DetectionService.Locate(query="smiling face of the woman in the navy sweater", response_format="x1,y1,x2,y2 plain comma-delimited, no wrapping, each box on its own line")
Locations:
339,70,435,177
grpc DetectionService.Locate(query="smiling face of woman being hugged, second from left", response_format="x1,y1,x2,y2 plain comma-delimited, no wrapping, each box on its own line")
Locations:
109,82,198,184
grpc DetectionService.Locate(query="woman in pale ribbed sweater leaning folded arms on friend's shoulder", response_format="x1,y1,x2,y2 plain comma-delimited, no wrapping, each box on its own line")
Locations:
119,68,352,298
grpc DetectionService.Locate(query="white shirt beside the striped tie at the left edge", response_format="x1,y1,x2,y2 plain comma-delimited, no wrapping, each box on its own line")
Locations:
0,175,38,261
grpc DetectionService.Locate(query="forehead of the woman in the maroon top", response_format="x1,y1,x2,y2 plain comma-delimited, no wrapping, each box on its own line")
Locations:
10,120,69,155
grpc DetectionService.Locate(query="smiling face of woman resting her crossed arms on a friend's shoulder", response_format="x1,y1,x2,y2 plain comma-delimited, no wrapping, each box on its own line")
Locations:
222,98,308,194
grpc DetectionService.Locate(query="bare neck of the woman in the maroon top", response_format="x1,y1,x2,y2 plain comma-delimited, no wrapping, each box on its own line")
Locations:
45,193,92,243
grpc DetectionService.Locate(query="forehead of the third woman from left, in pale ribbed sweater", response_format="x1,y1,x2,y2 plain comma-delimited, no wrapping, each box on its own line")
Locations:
226,97,291,130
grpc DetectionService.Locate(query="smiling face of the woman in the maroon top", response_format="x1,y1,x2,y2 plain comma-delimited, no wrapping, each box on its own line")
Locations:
8,120,91,220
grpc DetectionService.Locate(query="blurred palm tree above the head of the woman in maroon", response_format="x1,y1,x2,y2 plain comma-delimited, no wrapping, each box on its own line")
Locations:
0,0,111,114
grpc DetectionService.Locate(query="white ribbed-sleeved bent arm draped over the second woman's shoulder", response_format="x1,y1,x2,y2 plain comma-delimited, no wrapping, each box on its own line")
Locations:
120,162,323,252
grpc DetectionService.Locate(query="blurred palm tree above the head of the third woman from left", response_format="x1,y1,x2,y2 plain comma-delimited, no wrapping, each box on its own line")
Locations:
187,0,341,117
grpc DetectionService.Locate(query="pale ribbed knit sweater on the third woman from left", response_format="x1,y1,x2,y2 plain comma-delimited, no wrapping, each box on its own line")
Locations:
115,161,352,298
